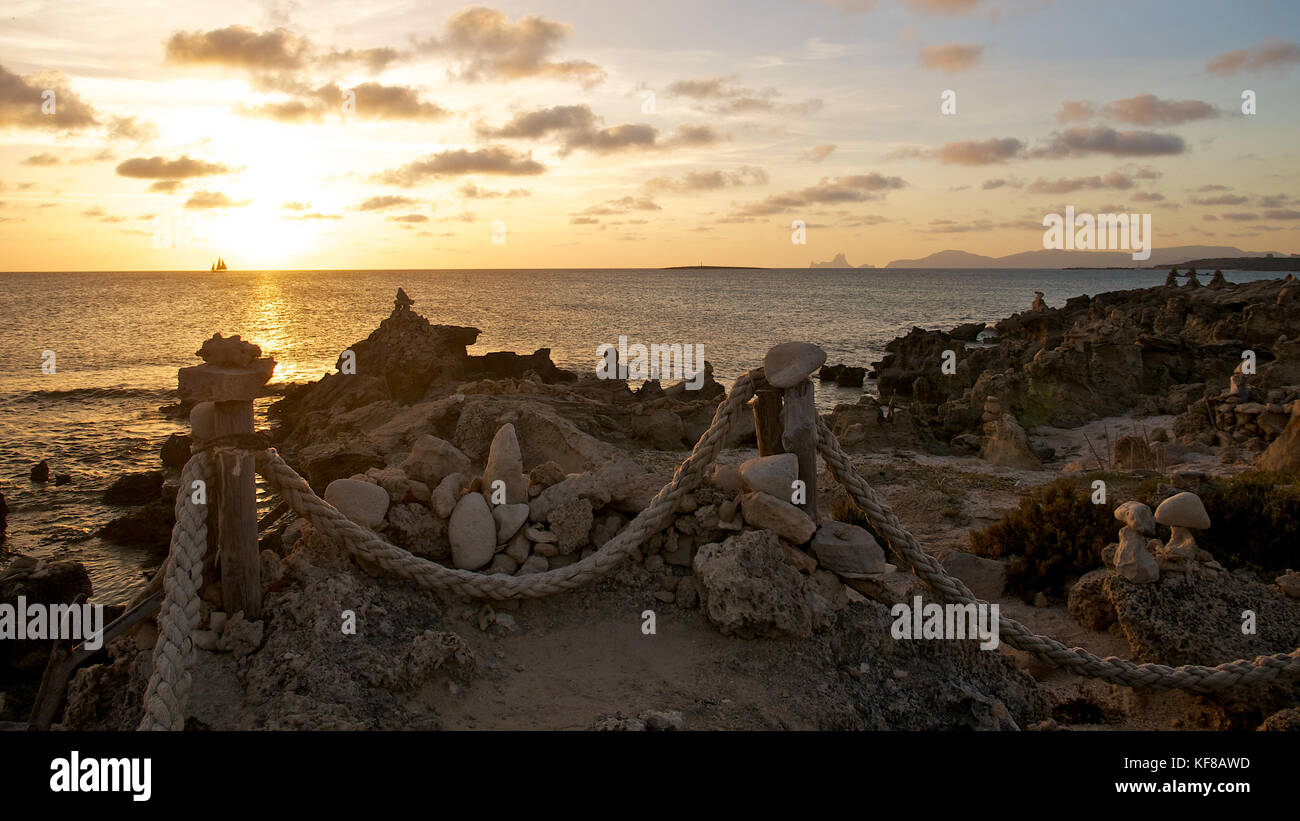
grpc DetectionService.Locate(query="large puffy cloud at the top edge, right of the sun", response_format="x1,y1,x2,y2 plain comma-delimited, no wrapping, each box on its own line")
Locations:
417,6,605,86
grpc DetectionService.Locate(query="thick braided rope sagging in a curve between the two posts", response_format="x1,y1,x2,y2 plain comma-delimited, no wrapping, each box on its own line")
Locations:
257,373,755,599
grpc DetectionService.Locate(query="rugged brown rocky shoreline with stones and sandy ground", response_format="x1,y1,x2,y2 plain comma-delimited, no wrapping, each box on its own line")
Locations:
0,278,1300,729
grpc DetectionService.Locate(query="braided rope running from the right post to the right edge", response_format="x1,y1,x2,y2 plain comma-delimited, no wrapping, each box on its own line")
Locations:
818,420,1300,692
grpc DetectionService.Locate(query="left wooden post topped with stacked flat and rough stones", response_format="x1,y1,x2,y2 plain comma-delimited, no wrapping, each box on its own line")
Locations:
178,334,276,620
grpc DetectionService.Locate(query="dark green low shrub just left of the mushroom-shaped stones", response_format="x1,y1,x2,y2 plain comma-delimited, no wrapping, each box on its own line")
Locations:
971,477,1121,601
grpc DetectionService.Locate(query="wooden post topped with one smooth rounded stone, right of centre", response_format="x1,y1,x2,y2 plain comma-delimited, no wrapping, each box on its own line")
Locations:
755,342,826,525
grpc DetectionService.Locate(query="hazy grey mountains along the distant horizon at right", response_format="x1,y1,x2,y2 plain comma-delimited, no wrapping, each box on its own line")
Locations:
878,246,1287,268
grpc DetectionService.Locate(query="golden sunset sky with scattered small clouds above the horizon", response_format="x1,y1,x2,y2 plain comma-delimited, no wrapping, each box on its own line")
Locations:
0,0,1300,270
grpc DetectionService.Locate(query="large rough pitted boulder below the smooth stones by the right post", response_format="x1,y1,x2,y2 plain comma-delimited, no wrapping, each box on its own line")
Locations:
694,530,813,638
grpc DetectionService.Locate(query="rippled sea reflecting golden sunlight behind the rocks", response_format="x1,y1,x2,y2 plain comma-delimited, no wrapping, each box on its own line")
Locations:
0,269,1284,603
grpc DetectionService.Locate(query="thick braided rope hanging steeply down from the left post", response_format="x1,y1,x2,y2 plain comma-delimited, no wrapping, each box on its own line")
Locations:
139,452,211,730
